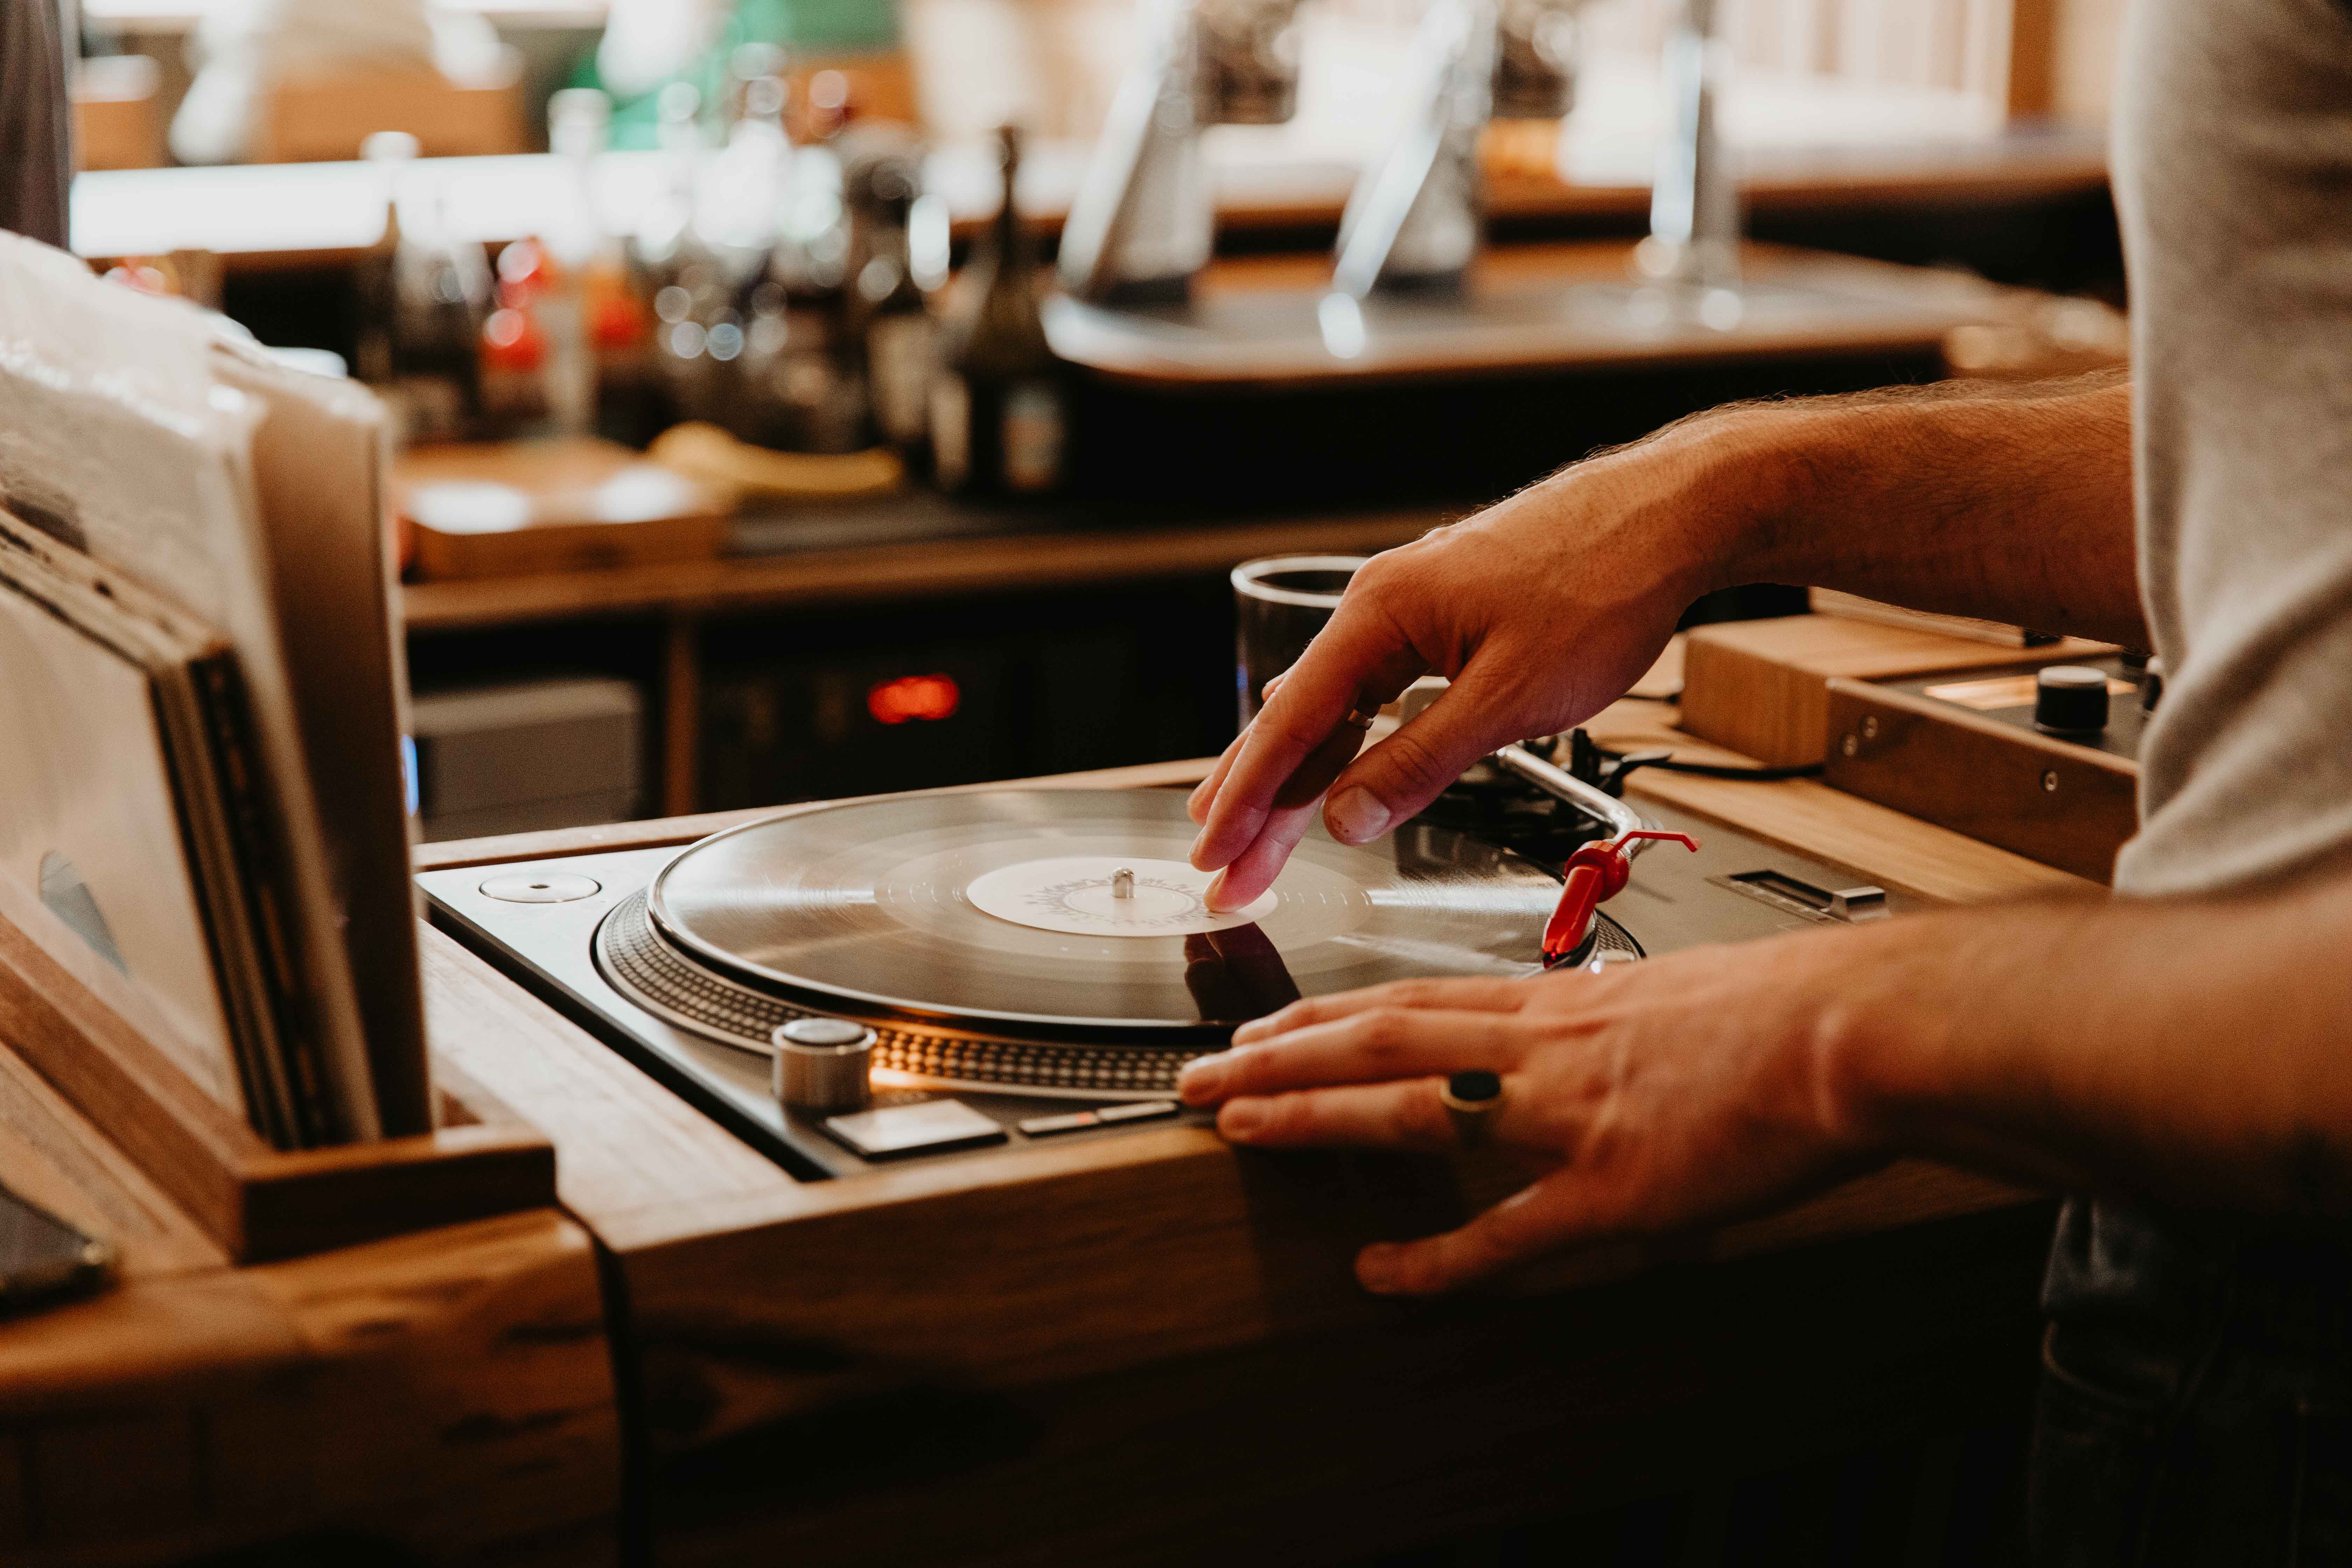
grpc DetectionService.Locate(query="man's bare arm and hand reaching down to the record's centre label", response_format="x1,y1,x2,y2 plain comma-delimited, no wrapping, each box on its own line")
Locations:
1190,376,2147,910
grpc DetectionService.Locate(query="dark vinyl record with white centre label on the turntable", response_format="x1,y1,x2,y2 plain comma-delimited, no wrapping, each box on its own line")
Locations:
647,790,1559,1044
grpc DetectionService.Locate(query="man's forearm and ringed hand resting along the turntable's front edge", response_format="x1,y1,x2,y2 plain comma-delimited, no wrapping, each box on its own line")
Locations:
1181,872,2352,1293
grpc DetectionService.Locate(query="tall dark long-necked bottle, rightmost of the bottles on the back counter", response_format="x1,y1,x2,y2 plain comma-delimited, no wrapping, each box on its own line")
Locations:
931,125,1068,496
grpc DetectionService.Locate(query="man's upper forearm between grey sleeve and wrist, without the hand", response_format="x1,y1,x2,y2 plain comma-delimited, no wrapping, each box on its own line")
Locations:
1670,374,2147,646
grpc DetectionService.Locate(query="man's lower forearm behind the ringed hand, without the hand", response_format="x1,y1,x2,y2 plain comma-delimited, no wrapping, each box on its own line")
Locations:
1818,882,2352,1225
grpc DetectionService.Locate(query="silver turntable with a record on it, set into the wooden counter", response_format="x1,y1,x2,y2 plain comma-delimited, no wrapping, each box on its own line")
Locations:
419,769,1905,1180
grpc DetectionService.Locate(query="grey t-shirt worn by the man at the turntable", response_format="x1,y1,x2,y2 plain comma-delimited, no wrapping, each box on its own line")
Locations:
2114,0,2352,893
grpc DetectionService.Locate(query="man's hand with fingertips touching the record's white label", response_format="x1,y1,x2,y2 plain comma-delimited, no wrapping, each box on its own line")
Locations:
1190,421,1764,910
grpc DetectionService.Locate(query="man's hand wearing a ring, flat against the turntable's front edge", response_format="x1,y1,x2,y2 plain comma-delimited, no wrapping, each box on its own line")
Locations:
1183,933,1886,1295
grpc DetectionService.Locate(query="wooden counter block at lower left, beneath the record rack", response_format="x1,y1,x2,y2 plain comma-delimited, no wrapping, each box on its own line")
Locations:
0,1208,621,1568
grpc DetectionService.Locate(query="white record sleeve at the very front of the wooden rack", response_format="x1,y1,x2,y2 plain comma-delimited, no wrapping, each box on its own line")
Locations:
0,588,245,1116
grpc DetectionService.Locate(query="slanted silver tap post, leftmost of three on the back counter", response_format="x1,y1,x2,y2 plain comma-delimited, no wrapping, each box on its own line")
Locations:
1058,0,1298,303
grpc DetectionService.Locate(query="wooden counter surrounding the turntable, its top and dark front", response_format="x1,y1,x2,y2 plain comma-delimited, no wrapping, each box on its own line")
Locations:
426,752,2088,1563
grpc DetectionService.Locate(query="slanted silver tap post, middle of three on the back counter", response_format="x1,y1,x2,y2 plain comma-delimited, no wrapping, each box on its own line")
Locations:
1331,0,1583,299
